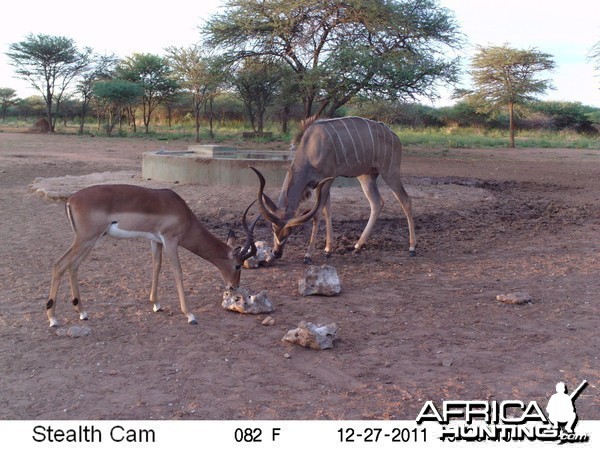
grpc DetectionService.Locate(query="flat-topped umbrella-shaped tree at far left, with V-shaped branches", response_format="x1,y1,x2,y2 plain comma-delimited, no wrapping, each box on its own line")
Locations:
6,34,92,132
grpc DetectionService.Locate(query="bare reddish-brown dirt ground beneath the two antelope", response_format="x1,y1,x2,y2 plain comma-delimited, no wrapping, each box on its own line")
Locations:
0,132,600,420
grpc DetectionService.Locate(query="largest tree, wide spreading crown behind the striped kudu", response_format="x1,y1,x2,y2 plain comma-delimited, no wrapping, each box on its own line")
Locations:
203,0,461,117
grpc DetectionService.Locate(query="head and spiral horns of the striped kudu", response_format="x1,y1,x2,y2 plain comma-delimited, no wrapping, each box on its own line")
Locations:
250,166,333,258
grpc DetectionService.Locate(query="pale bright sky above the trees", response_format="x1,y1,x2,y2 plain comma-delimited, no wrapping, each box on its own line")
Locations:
0,0,600,107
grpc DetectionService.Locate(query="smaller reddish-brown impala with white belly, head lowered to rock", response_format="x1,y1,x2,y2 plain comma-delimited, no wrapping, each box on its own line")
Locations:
46,185,261,327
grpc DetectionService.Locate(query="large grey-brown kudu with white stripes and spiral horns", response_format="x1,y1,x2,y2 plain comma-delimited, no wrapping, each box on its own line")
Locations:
254,117,417,263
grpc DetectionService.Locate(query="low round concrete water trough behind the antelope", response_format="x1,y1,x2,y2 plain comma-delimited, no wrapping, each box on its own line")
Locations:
142,145,358,186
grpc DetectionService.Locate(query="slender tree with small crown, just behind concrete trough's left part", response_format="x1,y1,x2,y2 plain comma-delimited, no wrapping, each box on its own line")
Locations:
166,45,223,142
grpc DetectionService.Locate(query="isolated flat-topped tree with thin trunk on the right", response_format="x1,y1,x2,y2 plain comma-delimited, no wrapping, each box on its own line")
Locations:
457,44,555,148
